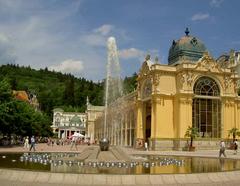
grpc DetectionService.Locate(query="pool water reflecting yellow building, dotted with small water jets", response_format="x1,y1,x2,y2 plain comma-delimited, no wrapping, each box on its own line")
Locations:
0,153,240,174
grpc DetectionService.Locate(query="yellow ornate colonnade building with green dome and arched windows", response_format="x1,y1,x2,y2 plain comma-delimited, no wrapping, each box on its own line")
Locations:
91,30,240,150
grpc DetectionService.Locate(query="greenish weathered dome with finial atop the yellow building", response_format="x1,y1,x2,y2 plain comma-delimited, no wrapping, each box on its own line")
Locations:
168,28,207,65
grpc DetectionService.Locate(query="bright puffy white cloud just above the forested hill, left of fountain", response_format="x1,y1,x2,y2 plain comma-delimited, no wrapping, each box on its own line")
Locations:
49,59,84,74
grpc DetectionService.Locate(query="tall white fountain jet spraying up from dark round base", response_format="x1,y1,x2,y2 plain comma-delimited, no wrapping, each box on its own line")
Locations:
99,37,122,151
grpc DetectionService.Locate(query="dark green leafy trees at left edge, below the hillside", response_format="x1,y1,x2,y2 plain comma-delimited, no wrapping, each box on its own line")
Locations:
0,80,52,136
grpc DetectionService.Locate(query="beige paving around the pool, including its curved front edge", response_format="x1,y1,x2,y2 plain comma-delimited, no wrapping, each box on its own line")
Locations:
0,144,240,186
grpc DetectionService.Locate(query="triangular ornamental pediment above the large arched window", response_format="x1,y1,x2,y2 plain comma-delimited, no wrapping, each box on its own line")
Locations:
195,52,223,73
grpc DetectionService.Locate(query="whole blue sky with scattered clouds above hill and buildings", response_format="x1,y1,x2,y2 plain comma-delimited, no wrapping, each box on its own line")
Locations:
0,0,240,81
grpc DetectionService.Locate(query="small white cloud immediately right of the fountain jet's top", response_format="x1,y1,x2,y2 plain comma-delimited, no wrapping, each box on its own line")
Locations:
118,48,145,59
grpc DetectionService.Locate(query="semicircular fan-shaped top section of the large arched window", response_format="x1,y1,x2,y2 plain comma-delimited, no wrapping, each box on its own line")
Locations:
193,77,220,96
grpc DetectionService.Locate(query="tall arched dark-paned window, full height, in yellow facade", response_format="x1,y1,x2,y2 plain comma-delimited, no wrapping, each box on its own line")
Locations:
192,77,221,138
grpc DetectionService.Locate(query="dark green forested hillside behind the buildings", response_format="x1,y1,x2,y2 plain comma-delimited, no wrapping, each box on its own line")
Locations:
0,64,137,115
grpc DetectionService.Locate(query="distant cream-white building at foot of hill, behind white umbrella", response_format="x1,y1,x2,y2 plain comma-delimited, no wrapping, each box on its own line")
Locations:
52,108,86,138
